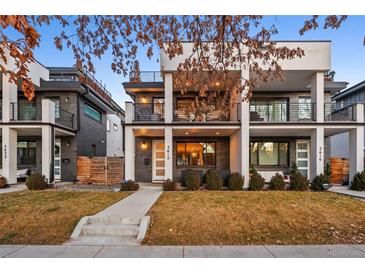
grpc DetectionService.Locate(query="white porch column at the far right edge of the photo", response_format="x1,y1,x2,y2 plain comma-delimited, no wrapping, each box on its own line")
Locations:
349,126,364,183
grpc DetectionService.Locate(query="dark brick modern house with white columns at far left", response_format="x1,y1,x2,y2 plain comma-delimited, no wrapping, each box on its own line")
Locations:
0,50,124,184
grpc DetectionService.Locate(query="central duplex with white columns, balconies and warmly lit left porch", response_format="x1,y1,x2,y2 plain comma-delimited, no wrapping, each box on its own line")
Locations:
124,41,364,188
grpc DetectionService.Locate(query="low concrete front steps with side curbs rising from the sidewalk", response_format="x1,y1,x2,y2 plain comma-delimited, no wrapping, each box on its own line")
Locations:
65,215,149,245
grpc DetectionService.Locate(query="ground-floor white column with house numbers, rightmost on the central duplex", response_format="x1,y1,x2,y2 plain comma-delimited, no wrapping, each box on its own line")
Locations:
309,127,324,180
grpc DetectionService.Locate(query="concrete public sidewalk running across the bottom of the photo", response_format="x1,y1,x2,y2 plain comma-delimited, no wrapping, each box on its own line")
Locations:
0,245,365,258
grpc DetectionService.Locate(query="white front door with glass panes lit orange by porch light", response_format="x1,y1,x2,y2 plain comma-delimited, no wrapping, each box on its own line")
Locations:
152,140,165,181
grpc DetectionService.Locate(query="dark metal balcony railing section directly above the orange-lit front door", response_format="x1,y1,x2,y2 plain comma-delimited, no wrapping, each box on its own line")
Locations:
134,103,165,122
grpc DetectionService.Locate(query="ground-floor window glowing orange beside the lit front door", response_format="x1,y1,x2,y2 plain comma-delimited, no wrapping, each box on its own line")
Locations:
176,142,216,166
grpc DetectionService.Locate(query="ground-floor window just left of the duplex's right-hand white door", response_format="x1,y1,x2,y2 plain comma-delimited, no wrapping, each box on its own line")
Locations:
250,142,289,166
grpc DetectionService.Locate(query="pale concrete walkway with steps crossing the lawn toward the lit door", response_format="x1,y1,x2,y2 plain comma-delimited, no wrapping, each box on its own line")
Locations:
64,186,162,246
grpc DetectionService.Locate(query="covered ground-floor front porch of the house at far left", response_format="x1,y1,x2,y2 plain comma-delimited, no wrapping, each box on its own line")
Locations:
0,124,76,184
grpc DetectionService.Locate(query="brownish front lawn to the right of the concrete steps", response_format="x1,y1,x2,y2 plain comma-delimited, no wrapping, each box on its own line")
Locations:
144,191,365,245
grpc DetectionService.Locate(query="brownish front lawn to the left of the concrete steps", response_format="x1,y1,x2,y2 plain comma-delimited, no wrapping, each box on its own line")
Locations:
0,190,130,244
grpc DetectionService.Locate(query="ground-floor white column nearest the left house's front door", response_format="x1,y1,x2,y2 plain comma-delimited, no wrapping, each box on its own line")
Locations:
42,126,54,184
